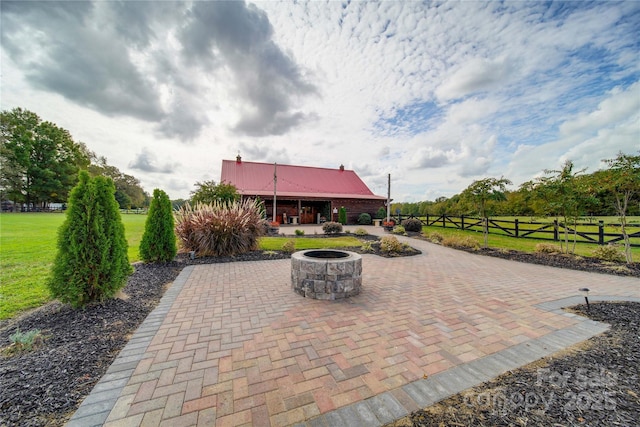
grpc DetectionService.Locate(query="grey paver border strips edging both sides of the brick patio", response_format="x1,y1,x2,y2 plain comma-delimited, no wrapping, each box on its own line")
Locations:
67,265,640,427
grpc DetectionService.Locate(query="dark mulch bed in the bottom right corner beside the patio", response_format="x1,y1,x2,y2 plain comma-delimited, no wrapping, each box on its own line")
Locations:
388,303,640,427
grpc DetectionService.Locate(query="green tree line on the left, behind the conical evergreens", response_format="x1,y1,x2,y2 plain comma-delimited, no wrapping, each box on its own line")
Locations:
0,108,150,211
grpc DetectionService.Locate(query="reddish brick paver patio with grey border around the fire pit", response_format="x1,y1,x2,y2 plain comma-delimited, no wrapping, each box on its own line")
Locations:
68,226,640,427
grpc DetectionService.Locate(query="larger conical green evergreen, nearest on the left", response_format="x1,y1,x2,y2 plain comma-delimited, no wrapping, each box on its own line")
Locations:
47,171,132,307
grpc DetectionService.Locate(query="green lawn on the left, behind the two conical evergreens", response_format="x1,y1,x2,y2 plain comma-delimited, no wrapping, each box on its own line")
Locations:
0,213,147,320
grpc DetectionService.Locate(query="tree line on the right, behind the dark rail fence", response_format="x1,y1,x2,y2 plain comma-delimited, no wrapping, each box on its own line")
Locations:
391,152,640,221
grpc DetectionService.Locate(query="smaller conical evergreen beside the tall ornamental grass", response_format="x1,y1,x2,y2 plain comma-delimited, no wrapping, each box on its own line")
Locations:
140,188,178,262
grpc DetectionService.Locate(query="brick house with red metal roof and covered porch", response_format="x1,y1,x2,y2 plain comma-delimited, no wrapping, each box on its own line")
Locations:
220,156,387,224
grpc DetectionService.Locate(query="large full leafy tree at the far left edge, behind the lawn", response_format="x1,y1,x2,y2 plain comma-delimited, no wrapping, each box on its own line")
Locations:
0,108,89,207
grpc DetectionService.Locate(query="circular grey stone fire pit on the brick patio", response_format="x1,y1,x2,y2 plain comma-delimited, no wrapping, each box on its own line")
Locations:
291,249,362,300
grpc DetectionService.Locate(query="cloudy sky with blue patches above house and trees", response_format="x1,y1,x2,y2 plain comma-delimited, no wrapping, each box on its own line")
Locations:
0,0,640,201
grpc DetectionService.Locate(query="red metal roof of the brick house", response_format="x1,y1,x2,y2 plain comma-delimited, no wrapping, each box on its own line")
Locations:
220,160,386,200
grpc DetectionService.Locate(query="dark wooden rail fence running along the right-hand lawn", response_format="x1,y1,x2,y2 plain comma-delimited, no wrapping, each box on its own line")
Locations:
394,215,640,247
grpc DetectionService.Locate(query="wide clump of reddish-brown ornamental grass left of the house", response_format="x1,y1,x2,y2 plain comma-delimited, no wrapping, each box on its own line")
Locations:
175,199,267,257
